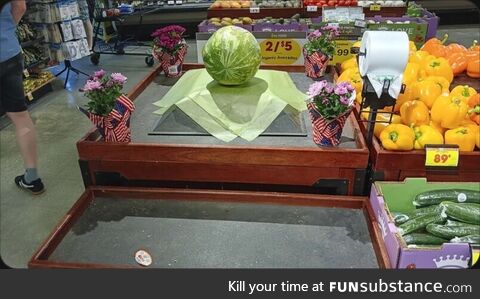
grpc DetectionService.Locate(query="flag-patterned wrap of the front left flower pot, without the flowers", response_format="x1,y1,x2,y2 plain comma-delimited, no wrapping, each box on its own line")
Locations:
78,95,135,142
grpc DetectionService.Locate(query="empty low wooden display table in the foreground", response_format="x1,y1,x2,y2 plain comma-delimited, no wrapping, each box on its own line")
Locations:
28,187,390,268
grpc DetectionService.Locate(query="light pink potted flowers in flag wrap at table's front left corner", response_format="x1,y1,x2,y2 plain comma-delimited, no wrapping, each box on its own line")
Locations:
78,70,135,142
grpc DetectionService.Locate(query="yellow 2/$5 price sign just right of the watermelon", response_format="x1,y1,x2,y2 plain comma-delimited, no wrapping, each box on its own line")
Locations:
260,38,302,64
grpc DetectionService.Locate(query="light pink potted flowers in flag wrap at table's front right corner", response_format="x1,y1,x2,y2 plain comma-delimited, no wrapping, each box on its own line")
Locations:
307,80,355,146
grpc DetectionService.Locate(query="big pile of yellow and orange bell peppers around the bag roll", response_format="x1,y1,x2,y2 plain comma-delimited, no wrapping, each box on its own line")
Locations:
337,37,480,151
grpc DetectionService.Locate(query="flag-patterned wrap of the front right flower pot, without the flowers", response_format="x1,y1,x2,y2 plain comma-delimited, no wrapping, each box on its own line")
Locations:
307,103,352,146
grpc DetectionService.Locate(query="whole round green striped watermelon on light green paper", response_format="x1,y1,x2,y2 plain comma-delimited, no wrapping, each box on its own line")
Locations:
202,26,262,85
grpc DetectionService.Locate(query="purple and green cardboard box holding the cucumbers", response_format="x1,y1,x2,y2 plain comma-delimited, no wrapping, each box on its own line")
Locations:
370,178,480,269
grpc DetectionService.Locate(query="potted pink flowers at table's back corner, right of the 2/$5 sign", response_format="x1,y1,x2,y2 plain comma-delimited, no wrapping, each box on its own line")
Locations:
303,25,339,78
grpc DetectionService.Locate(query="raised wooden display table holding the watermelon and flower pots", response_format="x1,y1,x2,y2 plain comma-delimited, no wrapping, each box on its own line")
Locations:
77,64,369,195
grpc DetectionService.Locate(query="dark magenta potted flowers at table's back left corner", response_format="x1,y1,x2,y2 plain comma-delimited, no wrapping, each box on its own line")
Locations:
151,25,187,77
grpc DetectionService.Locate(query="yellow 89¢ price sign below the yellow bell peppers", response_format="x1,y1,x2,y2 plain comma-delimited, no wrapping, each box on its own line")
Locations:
425,144,460,167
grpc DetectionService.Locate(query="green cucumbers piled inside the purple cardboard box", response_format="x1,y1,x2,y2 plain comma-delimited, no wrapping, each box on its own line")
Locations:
392,189,480,246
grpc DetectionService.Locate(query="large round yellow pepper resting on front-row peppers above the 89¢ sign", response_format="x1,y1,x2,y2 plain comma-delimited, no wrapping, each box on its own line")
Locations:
430,95,468,129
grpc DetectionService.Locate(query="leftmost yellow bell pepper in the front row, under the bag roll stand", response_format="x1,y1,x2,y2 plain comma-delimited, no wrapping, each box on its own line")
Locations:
380,124,415,151
